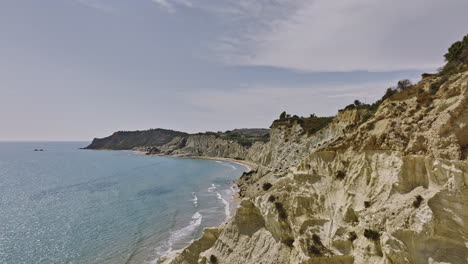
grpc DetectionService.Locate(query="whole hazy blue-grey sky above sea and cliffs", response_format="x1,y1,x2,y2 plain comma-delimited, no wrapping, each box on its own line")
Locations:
0,0,468,141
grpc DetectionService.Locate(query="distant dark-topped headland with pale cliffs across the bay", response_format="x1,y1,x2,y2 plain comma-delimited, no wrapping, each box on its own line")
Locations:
85,128,270,159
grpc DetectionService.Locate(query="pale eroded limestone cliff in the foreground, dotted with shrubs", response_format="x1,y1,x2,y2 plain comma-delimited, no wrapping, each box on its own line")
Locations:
160,72,468,264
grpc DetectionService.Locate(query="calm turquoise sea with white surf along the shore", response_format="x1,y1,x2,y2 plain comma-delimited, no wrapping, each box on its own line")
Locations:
0,142,247,264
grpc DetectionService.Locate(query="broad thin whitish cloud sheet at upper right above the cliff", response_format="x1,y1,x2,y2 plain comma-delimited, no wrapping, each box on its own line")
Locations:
217,0,468,71
